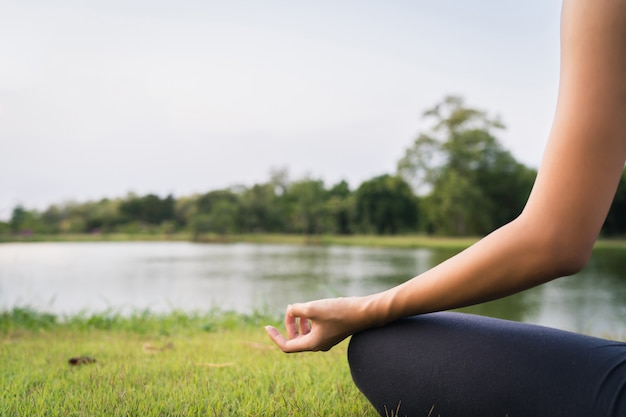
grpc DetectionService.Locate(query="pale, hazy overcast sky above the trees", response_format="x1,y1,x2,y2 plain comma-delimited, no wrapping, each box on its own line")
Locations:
0,0,560,220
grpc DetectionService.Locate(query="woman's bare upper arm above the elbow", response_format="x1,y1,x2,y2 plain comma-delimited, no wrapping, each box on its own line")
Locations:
521,0,626,270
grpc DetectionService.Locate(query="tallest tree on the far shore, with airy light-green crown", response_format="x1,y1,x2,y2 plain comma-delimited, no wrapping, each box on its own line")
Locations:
398,96,535,235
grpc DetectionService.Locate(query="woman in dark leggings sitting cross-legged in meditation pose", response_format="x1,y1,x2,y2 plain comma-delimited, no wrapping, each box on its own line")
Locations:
267,0,626,417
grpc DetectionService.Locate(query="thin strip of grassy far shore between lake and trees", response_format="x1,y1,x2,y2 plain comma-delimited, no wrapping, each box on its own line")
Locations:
0,233,626,250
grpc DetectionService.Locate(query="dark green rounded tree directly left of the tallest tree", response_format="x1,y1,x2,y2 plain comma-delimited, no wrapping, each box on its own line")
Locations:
355,174,417,234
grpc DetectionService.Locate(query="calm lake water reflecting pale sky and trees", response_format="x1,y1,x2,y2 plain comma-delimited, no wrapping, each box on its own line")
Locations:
0,242,626,338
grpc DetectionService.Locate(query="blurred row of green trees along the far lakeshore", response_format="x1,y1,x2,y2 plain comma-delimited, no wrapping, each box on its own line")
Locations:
0,96,626,239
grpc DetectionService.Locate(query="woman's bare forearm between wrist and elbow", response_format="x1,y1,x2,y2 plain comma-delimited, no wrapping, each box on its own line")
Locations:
364,214,586,325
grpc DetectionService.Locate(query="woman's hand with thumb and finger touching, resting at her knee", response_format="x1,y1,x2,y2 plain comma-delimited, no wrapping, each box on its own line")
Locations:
265,297,368,353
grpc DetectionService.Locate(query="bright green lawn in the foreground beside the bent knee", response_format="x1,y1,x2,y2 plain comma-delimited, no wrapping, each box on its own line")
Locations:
0,308,376,416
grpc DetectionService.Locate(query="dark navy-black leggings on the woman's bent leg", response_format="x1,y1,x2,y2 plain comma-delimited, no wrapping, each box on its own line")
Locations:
348,313,626,417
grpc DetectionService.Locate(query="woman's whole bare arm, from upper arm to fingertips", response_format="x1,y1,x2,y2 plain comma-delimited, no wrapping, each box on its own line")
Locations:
266,0,626,352
